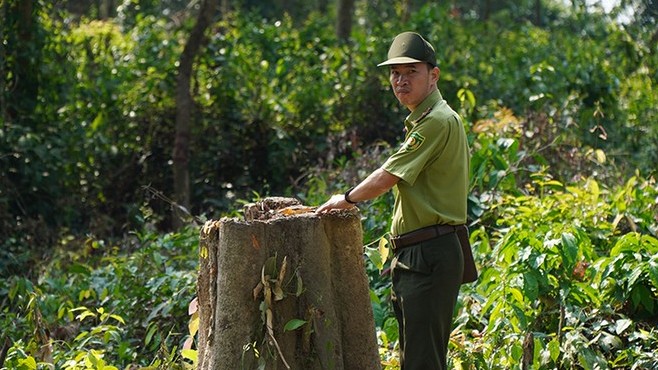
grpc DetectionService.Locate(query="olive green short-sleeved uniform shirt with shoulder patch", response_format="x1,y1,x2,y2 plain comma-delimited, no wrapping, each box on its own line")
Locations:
382,89,469,236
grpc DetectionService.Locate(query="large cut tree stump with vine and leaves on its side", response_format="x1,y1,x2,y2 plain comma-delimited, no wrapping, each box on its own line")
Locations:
197,198,381,370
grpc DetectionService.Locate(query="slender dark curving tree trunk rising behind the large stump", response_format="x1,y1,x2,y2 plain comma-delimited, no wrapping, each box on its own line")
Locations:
173,0,219,228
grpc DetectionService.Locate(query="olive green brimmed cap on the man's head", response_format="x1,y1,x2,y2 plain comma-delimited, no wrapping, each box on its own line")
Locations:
377,32,436,67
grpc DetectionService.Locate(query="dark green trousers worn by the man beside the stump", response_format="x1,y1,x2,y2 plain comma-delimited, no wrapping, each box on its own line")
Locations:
391,233,464,370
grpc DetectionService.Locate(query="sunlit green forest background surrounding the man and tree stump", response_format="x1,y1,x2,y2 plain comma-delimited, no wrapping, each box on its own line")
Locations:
0,0,658,369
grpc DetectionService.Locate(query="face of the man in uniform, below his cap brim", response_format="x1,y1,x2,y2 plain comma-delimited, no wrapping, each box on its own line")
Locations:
389,63,439,110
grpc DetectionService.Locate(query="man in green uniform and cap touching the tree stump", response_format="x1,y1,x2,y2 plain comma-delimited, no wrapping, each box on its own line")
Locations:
317,32,469,370
